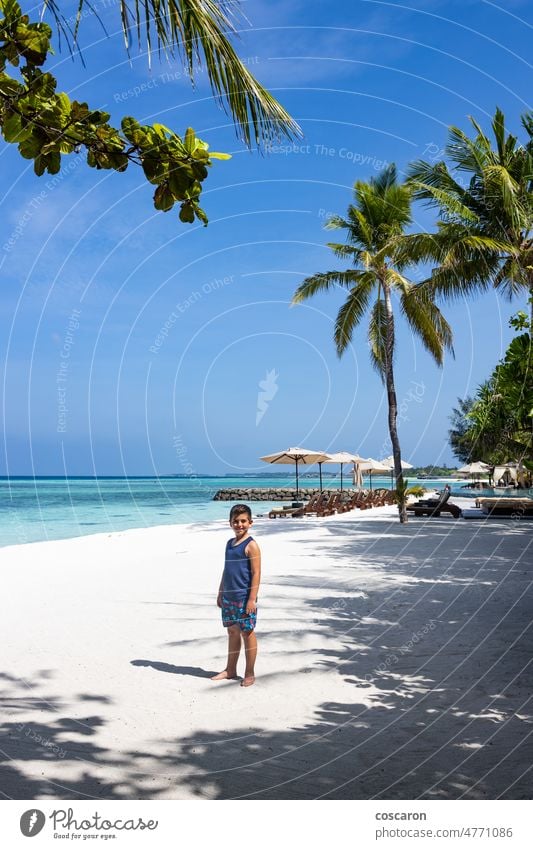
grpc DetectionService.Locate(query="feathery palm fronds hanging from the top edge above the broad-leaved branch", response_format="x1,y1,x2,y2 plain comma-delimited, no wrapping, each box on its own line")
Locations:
44,0,301,147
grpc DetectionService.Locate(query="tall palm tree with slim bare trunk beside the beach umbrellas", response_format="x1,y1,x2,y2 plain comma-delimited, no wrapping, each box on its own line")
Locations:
293,165,452,522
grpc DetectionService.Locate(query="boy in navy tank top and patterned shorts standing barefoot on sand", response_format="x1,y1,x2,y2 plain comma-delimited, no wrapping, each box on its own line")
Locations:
211,504,261,687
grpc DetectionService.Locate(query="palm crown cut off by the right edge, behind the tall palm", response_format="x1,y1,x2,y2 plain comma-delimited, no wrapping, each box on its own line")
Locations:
408,109,533,299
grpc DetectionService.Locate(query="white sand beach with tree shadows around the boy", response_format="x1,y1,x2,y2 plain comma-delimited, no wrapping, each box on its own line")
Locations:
0,507,533,799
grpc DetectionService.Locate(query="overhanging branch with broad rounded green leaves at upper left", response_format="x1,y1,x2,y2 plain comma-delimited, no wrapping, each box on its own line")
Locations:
0,0,230,224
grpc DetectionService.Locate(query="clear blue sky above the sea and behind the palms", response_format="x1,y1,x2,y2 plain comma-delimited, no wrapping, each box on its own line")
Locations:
0,0,533,474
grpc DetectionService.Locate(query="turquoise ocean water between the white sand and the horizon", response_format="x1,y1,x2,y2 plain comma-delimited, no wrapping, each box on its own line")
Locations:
0,472,516,546
